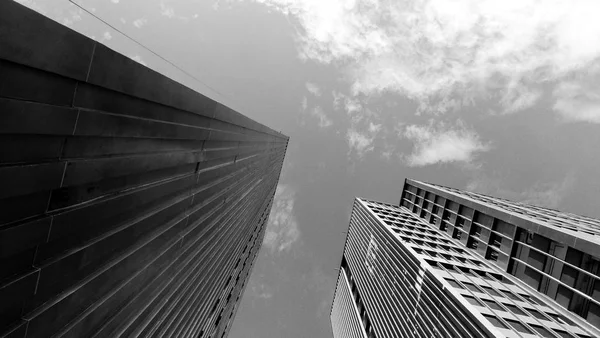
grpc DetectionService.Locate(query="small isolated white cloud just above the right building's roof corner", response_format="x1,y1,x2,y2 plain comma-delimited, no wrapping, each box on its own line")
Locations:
404,123,490,167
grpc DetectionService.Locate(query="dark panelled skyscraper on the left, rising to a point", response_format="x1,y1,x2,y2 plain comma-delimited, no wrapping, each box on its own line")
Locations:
0,1,288,337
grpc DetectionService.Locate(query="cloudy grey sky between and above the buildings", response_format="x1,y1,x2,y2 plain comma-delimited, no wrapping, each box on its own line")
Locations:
18,0,600,338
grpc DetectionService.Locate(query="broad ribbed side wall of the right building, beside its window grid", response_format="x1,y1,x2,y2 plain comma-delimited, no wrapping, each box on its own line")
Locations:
332,199,494,338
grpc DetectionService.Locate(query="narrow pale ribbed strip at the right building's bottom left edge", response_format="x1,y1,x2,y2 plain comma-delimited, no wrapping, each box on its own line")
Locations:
331,271,365,338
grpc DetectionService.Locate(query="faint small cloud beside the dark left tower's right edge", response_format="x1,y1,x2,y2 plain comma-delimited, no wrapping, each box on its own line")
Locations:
263,184,300,254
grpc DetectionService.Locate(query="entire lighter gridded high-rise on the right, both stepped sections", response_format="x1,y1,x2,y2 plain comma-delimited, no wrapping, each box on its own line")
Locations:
331,180,600,338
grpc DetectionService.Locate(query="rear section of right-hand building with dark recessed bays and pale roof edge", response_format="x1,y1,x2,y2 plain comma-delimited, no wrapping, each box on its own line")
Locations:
400,180,600,329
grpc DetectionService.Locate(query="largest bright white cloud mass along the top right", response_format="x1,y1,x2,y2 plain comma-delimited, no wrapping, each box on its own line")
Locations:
248,0,600,122
